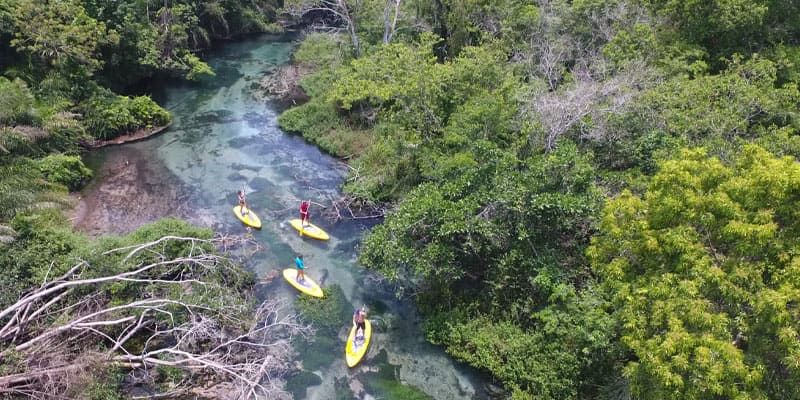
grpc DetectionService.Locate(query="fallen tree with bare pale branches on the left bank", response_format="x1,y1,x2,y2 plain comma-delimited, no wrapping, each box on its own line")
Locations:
0,236,309,399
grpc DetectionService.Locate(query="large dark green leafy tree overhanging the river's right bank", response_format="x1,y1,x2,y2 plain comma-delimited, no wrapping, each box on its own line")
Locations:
361,145,597,306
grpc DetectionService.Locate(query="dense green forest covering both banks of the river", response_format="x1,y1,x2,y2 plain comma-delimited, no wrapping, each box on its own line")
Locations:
0,0,800,400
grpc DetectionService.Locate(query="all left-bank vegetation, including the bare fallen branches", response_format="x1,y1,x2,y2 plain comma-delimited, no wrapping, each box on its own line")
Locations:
0,0,290,399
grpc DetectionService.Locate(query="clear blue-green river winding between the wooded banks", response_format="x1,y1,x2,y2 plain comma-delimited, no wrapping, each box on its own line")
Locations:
77,36,486,400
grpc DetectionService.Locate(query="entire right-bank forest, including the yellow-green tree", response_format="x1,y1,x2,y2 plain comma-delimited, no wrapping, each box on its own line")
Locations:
281,0,800,399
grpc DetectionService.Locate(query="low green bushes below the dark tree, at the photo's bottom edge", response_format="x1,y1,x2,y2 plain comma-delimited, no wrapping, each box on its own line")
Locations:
445,292,616,399
